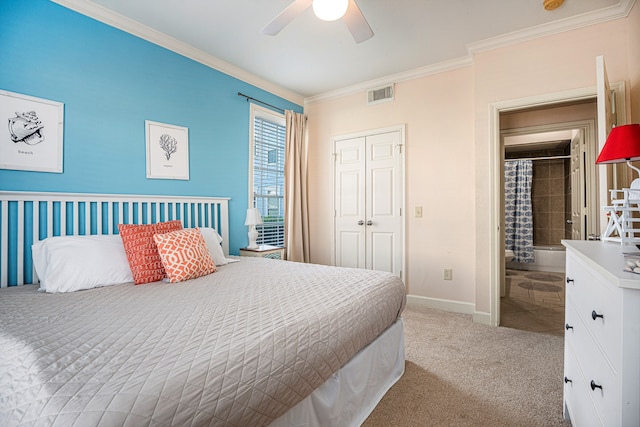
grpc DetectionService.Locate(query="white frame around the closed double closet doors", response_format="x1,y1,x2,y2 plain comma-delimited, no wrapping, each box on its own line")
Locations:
331,124,407,282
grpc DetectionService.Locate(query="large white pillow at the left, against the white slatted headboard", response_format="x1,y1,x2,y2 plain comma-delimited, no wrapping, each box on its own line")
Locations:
31,234,133,292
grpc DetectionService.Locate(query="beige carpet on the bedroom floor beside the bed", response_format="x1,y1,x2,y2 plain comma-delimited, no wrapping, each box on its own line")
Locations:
364,307,571,427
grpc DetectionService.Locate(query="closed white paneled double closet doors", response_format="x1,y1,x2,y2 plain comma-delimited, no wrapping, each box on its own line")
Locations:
334,131,404,276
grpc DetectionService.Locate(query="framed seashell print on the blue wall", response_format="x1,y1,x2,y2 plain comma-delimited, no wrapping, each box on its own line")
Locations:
0,90,64,173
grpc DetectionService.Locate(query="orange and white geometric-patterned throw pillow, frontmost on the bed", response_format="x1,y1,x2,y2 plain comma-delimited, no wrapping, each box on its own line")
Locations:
153,228,216,283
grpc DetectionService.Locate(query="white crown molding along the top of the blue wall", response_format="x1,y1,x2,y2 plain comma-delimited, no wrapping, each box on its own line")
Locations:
52,0,304,105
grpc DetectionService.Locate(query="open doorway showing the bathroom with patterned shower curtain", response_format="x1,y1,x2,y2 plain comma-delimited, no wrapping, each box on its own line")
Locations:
500,99,598,335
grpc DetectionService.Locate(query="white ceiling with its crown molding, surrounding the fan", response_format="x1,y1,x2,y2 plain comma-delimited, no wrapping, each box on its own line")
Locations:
54,0,635,103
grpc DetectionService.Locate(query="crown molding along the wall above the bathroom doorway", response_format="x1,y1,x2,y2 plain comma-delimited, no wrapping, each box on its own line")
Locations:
467,0,636,55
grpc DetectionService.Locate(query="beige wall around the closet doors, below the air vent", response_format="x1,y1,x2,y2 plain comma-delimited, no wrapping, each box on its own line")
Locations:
305,67,475,303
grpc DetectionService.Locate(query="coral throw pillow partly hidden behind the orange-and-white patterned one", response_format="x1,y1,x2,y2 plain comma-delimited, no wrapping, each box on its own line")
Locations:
118,220,182,285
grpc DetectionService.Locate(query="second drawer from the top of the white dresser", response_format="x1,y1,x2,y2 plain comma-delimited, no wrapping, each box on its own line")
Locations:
565,301,621,426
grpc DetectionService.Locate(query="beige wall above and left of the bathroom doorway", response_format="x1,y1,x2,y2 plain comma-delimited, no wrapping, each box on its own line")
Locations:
474,9,638,313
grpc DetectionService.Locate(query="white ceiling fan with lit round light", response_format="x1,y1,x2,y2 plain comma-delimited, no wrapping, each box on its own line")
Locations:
262,0,373,43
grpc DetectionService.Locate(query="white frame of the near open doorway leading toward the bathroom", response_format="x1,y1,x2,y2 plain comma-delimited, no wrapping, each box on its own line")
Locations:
489,82,626,326
